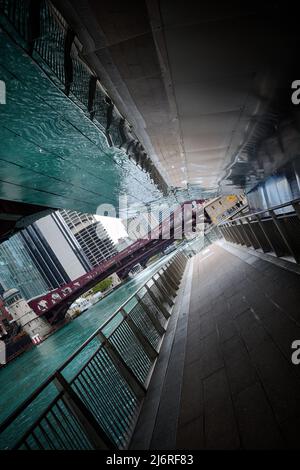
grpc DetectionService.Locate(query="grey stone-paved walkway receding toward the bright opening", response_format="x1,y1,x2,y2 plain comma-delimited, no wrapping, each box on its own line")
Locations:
132,245,300,449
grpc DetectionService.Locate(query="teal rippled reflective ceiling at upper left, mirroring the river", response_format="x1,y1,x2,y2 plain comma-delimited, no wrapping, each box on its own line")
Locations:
0,2,166,220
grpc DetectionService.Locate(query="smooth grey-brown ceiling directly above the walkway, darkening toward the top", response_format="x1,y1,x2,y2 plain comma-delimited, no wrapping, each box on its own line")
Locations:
55,0,299,194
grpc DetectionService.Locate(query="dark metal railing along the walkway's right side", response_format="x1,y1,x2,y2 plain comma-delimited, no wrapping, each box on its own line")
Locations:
215,199,300,264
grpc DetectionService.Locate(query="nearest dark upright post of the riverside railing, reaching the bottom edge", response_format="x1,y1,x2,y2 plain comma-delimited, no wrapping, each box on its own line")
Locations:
54,372,116,450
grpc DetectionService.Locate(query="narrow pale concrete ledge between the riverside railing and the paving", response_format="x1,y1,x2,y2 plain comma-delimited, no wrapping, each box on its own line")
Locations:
129,258,193,450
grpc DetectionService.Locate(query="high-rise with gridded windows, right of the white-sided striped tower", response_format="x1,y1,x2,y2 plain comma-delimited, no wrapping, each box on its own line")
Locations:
60,210,117,267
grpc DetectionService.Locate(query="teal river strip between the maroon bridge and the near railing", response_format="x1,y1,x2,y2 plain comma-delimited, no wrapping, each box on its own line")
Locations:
0,253,168,430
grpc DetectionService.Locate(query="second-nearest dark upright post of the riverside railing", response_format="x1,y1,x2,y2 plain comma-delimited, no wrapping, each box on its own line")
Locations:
98,331,146,399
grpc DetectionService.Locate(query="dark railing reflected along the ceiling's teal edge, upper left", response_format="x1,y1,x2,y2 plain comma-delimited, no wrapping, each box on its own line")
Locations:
0,0,168,193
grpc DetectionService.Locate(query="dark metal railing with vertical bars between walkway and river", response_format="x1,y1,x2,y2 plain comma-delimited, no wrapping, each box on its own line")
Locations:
0,251,187,450
